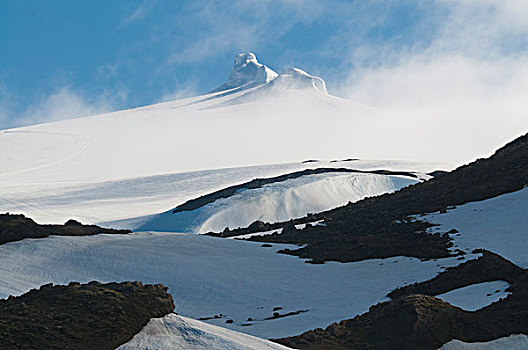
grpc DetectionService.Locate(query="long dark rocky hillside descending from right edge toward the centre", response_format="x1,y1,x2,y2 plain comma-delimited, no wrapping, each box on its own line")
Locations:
213,135,528,262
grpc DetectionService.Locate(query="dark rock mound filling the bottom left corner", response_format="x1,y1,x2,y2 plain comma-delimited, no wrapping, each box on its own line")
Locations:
0,282,174,350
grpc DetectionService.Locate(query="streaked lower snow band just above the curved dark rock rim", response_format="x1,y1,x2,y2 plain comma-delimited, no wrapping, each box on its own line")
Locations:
0,159,445,228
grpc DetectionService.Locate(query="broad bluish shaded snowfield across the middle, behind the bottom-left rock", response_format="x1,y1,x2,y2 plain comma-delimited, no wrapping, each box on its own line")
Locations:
0,233,466,339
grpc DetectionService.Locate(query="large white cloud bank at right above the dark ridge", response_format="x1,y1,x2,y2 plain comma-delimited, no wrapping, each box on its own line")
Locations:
334,0,528,162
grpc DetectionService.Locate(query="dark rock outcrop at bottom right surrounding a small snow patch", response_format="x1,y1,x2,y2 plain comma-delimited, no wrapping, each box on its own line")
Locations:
275,253,528,350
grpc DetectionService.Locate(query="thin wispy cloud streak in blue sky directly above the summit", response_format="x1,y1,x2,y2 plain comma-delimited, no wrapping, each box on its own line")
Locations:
167,0,324,64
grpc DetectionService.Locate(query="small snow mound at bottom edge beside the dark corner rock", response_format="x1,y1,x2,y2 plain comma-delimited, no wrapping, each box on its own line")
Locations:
118,314,289,350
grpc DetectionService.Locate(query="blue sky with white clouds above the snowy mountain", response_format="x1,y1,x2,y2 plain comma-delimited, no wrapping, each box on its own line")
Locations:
0,0,528,132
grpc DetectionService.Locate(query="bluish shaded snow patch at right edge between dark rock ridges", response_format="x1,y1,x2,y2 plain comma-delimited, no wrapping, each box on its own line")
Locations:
426,188,528,269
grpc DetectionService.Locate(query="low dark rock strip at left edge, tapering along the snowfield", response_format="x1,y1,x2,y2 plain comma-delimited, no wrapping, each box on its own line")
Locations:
0,213,131,244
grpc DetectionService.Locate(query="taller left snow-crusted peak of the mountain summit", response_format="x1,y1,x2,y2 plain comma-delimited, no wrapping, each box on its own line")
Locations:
211,52,278,92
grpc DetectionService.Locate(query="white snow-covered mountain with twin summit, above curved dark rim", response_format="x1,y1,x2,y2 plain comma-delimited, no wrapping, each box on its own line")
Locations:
0,53,450,229
